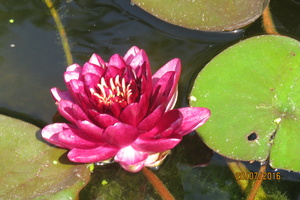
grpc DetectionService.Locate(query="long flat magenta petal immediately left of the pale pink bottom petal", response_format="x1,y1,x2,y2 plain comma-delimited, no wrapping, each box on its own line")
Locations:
68,144,119,163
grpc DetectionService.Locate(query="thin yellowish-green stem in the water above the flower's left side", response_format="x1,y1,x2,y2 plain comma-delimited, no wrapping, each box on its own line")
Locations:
45,0,73,65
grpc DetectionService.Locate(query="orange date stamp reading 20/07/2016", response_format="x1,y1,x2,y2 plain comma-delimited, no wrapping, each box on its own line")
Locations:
234,172,281,180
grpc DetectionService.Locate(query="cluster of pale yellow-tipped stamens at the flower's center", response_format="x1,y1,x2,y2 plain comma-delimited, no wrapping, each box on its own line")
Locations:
90,75,133,107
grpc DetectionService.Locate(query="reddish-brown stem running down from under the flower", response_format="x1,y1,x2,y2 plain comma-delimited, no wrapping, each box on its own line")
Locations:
142,167,175,200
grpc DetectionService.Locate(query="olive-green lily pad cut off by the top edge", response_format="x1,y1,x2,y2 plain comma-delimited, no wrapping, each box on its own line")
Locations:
132,0,269,31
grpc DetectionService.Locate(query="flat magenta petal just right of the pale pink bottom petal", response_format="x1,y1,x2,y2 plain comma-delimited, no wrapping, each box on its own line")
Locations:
132,138,181,152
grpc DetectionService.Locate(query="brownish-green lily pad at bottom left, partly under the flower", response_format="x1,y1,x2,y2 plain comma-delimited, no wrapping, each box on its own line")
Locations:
0,115,90,200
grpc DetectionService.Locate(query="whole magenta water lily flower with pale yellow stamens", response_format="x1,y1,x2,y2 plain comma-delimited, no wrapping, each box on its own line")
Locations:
42,46,210,172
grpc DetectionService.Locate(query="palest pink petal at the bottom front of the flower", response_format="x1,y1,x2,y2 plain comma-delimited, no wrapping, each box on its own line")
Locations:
114,146,148,165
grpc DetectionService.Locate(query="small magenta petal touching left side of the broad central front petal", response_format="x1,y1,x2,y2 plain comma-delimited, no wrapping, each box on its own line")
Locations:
77,120,104,141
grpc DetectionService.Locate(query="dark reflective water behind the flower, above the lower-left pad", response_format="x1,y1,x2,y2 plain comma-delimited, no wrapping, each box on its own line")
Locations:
0,0,240,123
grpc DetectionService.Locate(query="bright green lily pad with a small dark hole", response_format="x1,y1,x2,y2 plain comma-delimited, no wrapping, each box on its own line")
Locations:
190,36,300,171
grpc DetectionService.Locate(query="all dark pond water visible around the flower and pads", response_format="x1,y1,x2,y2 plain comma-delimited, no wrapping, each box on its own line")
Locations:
0,0,300,199
